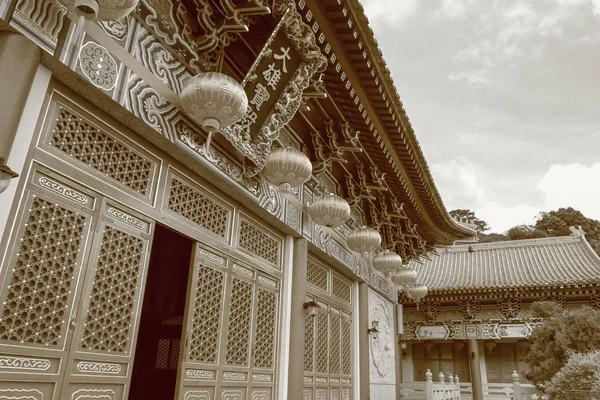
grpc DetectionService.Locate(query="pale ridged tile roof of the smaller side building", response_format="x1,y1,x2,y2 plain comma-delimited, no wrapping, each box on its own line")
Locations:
410,231,600,293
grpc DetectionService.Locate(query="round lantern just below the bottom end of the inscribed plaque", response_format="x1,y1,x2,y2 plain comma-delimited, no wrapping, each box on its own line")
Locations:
262,147,312,191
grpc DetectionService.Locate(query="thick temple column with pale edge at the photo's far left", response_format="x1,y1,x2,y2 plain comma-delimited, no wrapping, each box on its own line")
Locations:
0,30,51,241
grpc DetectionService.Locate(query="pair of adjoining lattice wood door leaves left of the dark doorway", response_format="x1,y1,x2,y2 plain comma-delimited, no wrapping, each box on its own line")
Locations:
0,169,153,400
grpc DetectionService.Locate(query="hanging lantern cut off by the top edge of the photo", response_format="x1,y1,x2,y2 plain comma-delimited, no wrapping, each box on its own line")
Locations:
59,0,139,37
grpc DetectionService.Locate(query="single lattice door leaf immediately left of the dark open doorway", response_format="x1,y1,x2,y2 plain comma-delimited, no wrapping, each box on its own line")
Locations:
60,202,153,400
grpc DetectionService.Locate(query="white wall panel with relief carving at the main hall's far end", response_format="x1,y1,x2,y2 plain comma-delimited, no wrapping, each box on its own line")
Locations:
369,289,396,400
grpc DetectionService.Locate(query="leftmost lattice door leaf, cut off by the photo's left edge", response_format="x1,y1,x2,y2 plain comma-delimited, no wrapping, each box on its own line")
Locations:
0,171,98,400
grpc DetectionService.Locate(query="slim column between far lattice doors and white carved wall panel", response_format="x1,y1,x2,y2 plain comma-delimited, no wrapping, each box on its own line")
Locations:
354,282,371,400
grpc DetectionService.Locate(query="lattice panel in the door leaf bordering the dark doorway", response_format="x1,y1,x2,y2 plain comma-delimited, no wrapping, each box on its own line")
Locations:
81,226,144,353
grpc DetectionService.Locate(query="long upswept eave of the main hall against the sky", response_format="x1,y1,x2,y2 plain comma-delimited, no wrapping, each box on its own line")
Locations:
306,0,476,245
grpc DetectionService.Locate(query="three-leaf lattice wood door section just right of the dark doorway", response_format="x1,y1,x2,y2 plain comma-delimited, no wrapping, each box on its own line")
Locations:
177,244,279,400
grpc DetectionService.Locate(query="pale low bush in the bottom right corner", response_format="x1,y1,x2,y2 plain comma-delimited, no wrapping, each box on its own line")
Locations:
546,350,600,400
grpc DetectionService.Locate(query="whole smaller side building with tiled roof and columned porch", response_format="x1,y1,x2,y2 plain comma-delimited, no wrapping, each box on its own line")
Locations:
400,228,600,400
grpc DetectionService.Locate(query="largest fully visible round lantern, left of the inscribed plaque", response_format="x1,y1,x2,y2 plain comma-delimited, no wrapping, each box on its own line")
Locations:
180,72,248,134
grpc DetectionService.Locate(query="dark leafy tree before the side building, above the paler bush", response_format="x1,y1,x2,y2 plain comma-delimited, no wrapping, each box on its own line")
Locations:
525,302,600,390
